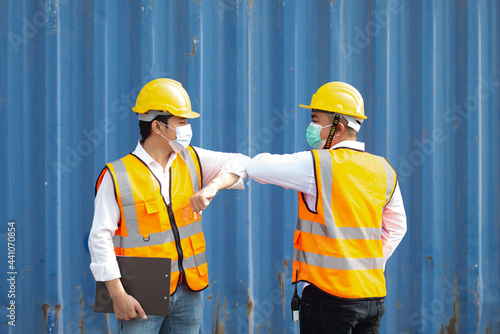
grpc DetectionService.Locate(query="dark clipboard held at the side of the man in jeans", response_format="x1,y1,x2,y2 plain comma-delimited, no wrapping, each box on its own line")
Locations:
95,256,171,315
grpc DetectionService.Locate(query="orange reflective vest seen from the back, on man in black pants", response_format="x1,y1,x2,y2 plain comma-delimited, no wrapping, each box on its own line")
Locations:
293,148,397,299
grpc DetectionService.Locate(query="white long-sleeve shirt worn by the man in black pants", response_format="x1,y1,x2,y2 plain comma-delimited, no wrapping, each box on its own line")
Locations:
247,140,406,268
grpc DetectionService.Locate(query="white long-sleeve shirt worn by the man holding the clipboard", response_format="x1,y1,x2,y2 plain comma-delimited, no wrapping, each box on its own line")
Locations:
89,143,250,281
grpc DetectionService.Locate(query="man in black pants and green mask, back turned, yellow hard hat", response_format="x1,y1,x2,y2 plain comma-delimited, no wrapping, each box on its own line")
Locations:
247,82,406,334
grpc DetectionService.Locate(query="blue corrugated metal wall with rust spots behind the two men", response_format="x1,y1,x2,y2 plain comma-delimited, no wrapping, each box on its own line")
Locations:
0,0,500,333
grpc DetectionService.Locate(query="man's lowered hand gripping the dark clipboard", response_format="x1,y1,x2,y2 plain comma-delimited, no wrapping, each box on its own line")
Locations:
105,278,147,320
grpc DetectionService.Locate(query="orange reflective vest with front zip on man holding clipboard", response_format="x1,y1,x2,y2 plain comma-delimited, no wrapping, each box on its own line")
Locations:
96,146,208,294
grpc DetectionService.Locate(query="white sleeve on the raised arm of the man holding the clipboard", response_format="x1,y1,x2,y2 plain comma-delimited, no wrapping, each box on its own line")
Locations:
194,147,250,189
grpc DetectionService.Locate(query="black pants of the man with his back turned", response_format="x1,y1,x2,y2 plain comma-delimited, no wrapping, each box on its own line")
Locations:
300,285,385,334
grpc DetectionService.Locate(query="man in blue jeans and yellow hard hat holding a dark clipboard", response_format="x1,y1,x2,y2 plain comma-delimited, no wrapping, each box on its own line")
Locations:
89,78,250,334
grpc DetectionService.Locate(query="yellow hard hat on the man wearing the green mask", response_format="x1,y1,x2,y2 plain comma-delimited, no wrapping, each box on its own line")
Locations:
300,81,366,119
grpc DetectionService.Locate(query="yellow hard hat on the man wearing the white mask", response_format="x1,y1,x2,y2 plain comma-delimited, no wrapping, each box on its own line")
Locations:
132,78,200,121
